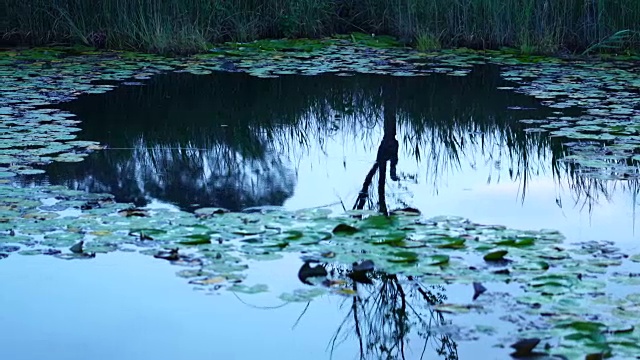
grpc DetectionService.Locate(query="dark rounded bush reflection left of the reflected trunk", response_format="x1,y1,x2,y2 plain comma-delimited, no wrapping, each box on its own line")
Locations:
31,136,295,211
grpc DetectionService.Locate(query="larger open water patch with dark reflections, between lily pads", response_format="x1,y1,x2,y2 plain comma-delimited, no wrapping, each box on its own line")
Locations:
20,65,637,245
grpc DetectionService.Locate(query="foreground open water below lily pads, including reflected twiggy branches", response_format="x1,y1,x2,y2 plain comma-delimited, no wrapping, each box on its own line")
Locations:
0,252,509,360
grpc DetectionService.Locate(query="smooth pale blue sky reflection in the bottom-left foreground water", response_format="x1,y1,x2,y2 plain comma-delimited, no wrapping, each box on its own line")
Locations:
0,253,516,360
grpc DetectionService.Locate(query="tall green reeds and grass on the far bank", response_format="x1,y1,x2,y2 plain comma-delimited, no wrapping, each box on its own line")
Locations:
0,0,640,52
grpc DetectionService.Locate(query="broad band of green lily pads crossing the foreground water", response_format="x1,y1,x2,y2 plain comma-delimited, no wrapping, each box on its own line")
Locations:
0,185,640,356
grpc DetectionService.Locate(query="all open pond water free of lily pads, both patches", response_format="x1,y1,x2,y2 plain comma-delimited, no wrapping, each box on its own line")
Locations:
0,57,638,359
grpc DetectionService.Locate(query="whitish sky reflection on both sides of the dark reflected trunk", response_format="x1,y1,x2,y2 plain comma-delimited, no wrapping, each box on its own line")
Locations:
285,127,636,250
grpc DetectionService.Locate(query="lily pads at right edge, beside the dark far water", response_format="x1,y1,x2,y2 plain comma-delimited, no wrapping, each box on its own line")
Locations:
502,61,640,179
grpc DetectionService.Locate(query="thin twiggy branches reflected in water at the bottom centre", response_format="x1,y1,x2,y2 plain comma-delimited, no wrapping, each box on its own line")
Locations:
303,264,458,360
